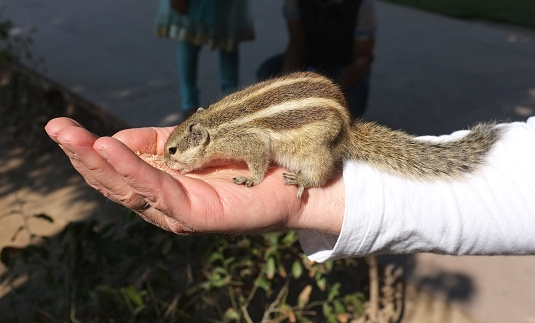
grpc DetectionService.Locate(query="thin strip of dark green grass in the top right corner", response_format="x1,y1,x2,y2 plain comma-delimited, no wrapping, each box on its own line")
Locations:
384,0,535,30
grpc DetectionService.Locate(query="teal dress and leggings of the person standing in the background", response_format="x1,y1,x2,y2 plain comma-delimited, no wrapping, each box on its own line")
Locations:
156,0,254,112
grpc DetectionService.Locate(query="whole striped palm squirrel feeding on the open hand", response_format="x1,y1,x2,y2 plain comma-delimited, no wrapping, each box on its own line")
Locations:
164,72,501,198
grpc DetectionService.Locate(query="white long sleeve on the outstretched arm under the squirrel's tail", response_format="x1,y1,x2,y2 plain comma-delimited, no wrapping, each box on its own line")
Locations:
299,117,535,261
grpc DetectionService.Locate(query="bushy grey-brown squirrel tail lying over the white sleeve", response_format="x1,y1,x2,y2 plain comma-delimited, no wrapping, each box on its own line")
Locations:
349,122,502,179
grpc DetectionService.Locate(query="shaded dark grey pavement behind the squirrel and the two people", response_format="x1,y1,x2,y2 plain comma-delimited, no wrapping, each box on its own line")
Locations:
2,0,535,134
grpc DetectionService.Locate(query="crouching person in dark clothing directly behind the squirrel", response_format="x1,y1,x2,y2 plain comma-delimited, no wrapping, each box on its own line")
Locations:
257,0,377,118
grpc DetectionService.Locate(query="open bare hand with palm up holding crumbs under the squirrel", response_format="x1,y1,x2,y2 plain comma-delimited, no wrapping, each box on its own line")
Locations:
45,118,345,234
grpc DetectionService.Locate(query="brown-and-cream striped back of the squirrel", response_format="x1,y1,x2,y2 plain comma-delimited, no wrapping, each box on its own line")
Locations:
188,72,350,134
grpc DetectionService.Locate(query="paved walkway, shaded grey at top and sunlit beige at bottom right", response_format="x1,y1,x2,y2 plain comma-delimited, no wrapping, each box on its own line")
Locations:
4,0,535,323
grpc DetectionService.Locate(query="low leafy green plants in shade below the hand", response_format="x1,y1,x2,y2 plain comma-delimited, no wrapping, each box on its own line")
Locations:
0,209,367,322
